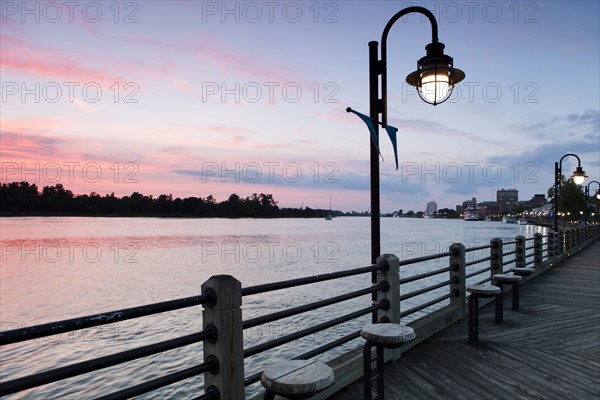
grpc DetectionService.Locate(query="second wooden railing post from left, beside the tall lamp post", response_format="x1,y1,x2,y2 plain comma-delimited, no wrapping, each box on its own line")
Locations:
377,254,400,324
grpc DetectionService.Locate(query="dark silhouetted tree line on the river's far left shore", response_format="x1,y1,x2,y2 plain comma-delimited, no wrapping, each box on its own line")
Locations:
0,182,332,218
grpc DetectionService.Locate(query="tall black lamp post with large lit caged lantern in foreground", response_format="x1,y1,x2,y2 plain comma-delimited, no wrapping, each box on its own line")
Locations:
346,7,465,264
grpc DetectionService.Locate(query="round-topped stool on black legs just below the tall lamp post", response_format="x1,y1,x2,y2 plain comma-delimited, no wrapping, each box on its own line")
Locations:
360,323,416,400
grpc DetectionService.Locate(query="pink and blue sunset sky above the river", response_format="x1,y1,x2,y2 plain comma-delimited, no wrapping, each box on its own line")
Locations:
0,1,600,212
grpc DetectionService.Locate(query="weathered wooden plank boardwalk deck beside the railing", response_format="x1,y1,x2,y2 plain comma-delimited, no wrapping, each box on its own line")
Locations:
330,241,600,400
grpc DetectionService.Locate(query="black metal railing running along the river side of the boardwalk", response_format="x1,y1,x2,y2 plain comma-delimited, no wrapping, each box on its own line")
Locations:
0,225,600,400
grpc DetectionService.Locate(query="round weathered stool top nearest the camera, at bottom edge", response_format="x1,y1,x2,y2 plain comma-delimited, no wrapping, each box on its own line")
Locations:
260,360,335,400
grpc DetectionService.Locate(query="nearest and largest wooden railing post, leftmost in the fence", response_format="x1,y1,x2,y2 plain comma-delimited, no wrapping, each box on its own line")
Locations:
202,275,245,399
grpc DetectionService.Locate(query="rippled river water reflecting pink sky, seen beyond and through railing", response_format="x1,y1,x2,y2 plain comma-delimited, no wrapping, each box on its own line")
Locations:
0,217,545,399
